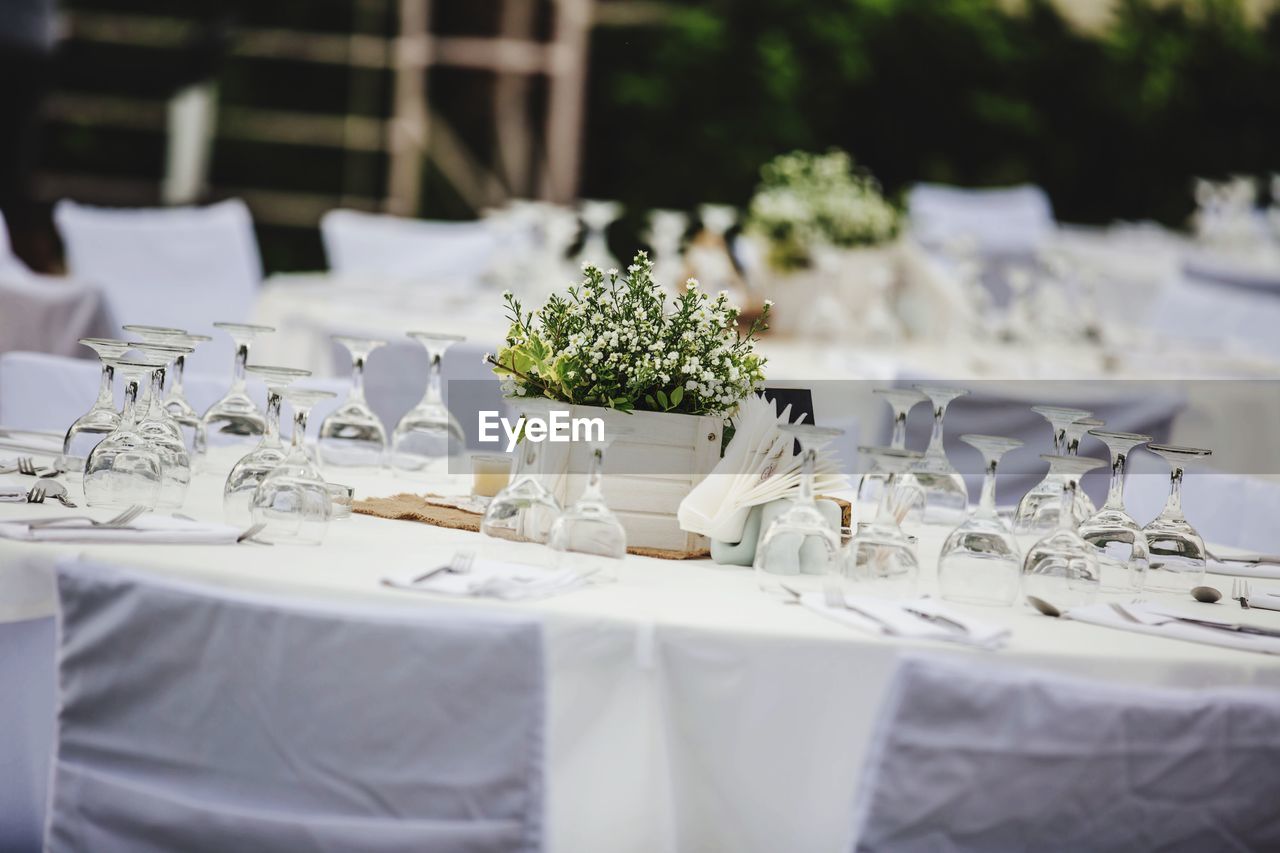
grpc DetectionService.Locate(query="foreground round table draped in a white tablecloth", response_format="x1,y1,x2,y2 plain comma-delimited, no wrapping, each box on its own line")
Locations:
0,448,1280,853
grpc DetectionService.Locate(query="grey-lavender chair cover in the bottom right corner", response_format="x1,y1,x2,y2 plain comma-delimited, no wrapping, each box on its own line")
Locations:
855,657,1280,853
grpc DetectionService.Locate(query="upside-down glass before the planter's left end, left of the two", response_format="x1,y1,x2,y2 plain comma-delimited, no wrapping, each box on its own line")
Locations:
480,398,561,566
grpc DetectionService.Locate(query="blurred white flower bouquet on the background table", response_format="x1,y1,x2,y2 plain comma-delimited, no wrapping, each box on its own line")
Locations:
748,149,902,269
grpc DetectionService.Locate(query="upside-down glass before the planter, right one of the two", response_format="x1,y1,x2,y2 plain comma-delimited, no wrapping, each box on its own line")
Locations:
547,424,632,583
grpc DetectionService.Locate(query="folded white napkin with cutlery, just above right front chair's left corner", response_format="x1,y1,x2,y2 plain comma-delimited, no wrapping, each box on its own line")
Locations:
800,593,1010,649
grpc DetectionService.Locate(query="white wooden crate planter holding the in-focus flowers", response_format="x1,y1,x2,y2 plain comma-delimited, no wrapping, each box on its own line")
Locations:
515,406,724,551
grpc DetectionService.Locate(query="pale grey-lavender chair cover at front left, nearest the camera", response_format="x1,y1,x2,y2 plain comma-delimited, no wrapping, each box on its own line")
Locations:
45,560,545,853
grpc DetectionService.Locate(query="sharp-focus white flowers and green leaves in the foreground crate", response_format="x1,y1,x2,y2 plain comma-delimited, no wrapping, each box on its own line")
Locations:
486,252,769,415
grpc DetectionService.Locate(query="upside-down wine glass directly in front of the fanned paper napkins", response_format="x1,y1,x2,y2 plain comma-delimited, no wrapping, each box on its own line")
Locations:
754,424,844,597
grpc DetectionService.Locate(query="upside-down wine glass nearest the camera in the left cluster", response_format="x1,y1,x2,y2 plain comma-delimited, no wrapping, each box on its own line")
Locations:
251,388,338,544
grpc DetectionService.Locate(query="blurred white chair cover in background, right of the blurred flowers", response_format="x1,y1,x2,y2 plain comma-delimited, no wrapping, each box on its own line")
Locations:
908,183,1053,255
